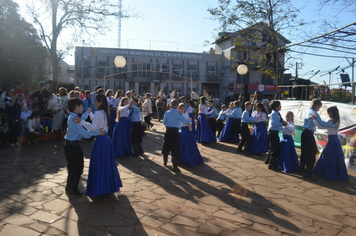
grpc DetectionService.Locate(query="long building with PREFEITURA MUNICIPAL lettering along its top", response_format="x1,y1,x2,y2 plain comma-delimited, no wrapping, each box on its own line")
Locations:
75,47,222,97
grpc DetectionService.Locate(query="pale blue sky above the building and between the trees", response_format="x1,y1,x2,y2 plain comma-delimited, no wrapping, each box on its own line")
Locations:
16,0,355,87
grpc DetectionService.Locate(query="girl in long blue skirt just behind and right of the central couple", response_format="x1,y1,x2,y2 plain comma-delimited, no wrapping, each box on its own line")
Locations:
196,97,216,143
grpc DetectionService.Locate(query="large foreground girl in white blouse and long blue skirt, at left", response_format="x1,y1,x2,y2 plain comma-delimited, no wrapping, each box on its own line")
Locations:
76,94,122,198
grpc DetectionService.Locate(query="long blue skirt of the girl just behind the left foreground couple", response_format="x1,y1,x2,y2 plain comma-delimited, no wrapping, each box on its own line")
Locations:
112,117,132,158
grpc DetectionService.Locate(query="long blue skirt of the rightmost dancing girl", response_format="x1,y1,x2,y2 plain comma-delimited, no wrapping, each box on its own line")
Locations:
313,135,349,181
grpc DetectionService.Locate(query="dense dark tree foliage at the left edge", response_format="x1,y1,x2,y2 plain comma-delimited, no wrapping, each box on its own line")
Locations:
0,0,49,89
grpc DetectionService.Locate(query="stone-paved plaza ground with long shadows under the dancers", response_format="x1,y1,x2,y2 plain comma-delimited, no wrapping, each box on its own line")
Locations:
0,121,356,236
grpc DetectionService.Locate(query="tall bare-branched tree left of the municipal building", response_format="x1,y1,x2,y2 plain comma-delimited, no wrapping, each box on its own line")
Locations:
28,0,137,91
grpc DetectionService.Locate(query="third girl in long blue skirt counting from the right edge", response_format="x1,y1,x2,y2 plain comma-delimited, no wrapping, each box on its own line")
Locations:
249,103,268,155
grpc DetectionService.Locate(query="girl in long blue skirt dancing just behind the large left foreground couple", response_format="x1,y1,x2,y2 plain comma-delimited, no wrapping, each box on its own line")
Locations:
112,97,132,158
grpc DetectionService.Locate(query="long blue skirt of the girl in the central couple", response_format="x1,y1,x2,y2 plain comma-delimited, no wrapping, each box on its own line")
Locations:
179,127,204,167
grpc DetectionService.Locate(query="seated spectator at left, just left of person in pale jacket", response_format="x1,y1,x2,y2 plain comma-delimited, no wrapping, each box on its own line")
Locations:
25,110,44,145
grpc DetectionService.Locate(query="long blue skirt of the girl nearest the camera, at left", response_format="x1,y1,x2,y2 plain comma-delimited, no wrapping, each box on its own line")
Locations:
85,135,122,197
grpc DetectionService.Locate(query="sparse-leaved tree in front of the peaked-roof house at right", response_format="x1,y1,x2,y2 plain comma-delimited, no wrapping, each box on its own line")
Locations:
208,0,303,97
